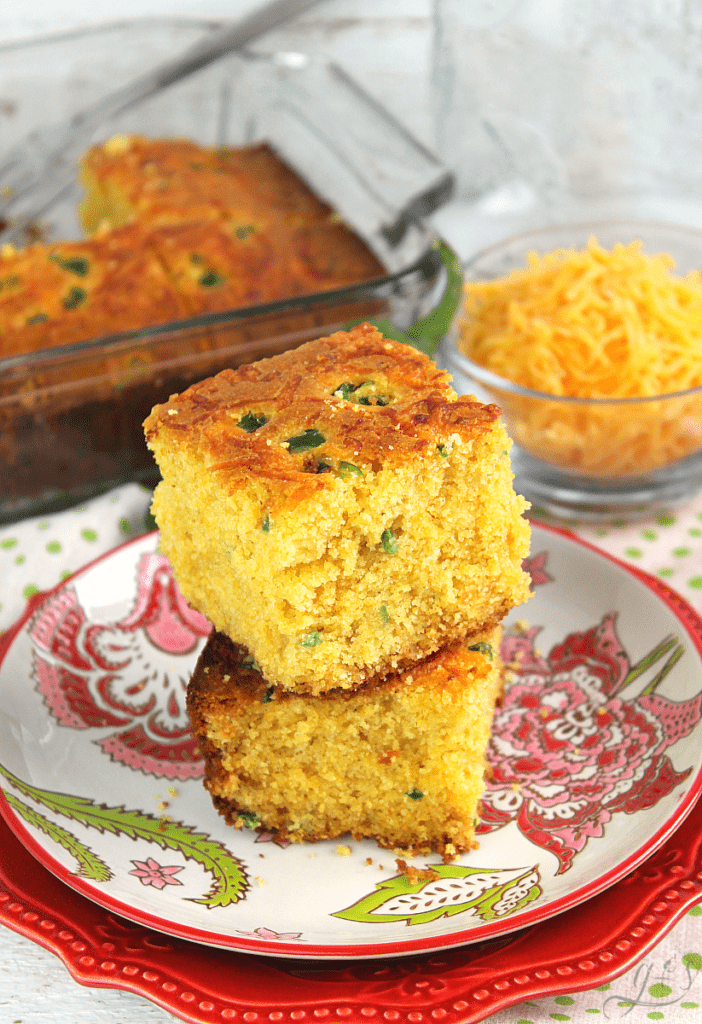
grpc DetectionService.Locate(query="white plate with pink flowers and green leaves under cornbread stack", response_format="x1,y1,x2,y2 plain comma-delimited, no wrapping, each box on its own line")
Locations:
0,526,702,958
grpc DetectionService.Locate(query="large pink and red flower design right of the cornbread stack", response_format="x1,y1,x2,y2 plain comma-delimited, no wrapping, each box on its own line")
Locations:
477,613,702,872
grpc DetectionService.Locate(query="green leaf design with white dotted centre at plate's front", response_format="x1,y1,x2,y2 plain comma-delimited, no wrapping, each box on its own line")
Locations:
333,864,541,925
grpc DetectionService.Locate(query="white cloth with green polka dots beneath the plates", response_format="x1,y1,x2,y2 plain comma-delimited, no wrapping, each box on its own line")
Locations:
0,484,702,1024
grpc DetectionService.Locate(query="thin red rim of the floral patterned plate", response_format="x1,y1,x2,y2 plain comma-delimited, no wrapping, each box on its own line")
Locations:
0,522,702,962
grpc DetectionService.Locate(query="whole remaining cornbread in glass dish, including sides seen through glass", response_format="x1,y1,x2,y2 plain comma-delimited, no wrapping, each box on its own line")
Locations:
0,136,390,515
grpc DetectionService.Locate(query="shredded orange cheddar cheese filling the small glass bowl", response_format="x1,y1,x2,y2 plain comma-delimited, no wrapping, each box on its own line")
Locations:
459,239,702,477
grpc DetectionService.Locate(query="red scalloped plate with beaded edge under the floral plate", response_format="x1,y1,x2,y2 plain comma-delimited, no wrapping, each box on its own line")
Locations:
0,804,702,1024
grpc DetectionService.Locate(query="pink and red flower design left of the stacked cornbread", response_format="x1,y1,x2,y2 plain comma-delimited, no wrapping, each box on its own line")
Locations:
30,553,211,780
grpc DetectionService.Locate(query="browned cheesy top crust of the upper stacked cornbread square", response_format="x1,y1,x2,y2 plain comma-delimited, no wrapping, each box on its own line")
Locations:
144,324,500,504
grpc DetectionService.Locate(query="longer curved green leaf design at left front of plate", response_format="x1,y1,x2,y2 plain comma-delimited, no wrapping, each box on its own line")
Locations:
0,765,249,908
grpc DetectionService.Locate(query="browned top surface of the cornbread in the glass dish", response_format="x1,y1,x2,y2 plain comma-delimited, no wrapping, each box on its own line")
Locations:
0,136,386,355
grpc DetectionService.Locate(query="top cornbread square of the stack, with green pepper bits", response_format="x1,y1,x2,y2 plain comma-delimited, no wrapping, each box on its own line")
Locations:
144,324,529,693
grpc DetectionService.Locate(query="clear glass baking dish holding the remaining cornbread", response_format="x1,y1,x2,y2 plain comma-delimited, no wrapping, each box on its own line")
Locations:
0,22,460,522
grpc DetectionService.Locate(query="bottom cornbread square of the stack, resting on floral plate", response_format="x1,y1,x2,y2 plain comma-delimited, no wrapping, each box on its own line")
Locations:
187,627,502,858
